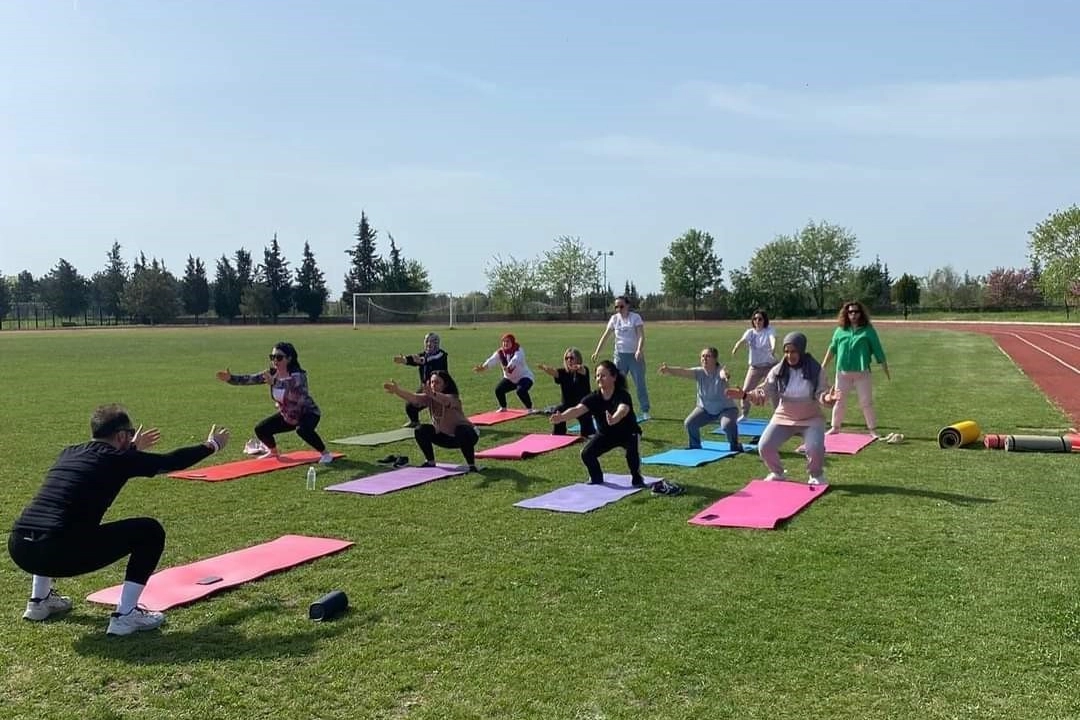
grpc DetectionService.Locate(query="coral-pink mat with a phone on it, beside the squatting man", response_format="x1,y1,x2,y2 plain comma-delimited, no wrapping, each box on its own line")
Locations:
86,535,353,612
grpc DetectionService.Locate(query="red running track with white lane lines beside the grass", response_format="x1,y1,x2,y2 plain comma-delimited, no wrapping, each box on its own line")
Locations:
897,322,1080,427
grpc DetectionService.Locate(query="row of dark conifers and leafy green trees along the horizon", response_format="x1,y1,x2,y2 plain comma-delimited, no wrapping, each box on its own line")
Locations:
0,205,1080,324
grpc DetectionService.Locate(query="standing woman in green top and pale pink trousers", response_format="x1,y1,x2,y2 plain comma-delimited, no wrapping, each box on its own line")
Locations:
821,300,892,437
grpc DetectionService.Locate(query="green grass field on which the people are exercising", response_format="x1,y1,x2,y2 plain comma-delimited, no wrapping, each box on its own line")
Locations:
0,324,1080,720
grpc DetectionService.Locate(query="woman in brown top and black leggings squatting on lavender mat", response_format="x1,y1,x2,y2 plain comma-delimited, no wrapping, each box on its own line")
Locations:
382,370,480,473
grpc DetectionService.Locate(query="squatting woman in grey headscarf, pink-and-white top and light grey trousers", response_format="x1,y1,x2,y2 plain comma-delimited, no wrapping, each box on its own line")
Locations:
728,332,840,485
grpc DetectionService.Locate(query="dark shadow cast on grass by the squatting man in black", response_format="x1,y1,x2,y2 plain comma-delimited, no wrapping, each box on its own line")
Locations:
66,603,380,665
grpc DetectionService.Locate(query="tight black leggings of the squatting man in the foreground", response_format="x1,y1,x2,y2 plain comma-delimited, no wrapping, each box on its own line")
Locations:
8,517,165,585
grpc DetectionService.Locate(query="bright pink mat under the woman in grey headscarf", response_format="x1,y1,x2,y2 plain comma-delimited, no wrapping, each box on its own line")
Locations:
689,480,828,530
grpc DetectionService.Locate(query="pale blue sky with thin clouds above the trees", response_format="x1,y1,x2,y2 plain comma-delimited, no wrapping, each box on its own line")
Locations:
0,0,1080,295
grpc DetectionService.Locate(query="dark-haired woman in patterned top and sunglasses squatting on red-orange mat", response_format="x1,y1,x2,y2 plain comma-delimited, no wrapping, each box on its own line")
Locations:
210,342,334,465
